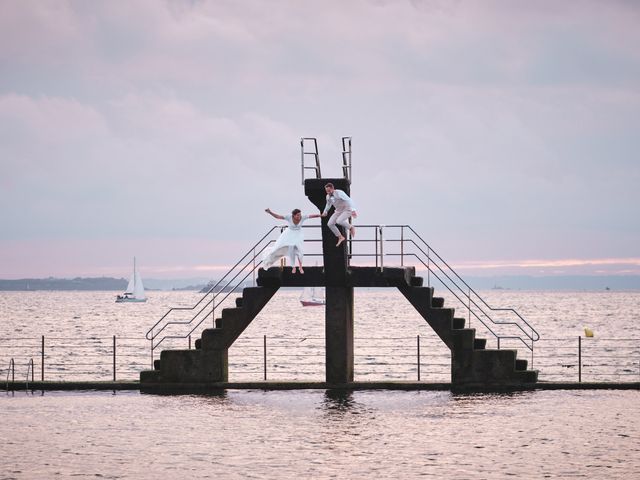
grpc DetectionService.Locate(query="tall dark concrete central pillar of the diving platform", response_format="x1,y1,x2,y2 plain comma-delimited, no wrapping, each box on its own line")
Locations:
304,178,353,384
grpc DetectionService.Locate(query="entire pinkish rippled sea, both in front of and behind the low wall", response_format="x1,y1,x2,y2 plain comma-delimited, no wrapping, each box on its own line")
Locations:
0,290,640,479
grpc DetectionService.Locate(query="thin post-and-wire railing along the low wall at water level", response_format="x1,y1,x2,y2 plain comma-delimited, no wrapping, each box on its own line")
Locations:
0,336,640,384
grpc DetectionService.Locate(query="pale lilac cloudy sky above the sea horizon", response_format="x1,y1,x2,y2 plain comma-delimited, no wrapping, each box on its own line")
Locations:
0,0,640,279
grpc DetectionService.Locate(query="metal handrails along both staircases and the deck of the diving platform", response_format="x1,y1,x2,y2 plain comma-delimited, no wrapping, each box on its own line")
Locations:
146,225,540,365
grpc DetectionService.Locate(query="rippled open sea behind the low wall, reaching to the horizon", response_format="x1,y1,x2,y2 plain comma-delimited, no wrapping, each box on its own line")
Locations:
0,289,640,382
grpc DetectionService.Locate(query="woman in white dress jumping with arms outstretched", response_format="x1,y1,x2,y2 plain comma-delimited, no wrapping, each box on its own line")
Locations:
262,208,320,273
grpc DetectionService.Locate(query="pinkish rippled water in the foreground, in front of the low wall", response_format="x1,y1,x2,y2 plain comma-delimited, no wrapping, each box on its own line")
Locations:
0,390,640,479
